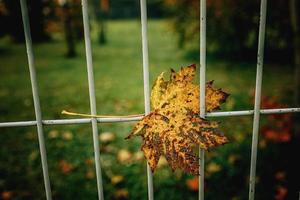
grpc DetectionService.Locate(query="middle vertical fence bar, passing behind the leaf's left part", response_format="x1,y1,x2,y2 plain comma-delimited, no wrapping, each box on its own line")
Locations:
140,0,154,200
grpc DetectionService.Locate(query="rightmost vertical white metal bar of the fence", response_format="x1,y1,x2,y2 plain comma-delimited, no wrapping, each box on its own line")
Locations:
249,0,267,200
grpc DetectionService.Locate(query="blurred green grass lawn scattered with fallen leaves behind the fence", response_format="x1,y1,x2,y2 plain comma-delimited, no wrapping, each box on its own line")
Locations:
0,20,293,199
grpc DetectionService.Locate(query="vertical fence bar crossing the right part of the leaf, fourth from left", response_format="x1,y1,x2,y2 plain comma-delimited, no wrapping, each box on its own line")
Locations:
199,0,206,200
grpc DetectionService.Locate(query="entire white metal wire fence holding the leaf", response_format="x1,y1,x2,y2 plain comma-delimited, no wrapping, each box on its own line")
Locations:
0,0,300,200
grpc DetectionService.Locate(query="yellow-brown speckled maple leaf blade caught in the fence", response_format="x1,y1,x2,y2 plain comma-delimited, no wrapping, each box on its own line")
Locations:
126,65,228,175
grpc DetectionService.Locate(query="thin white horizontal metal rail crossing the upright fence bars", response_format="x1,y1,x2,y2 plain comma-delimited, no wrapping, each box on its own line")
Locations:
0,108,300,128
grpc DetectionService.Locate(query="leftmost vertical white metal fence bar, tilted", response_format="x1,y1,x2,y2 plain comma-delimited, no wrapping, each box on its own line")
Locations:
20,0,52,200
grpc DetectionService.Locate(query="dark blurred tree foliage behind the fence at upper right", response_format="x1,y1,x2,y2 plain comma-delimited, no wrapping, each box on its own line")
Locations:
165,0,299,62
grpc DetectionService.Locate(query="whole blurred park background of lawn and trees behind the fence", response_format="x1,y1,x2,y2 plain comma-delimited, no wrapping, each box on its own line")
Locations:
0,0,300,200
